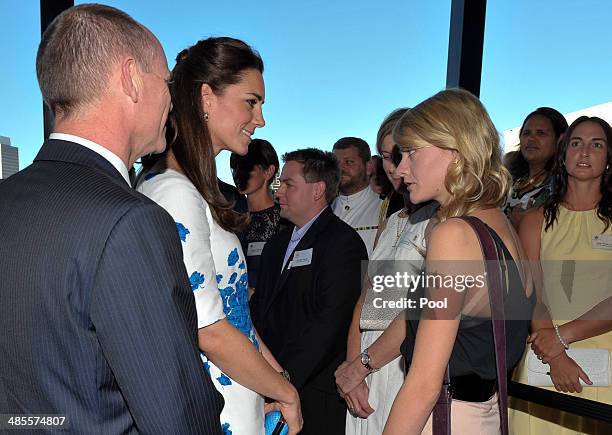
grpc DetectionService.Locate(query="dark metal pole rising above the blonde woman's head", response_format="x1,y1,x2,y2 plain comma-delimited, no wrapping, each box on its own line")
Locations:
446,0,487,97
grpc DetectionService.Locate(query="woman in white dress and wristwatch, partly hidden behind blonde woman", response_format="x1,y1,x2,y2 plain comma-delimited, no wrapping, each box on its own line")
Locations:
337,109,438,435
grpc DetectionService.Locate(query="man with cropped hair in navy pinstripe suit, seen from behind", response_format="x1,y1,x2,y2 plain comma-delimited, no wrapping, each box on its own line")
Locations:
0,5,223,434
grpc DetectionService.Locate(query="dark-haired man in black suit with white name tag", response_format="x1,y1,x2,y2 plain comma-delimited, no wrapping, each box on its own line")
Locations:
251,148,367,435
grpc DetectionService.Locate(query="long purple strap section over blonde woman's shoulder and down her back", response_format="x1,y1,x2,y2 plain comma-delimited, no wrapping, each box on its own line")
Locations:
462,216,508,435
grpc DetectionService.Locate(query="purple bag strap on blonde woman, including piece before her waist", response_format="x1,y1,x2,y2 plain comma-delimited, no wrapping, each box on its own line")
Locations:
432,216,508,435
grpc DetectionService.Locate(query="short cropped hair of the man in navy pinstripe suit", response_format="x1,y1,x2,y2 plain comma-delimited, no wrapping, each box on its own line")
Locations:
36,4,157,116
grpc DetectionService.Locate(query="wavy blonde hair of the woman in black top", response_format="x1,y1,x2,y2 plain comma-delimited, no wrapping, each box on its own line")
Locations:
393,89,510,222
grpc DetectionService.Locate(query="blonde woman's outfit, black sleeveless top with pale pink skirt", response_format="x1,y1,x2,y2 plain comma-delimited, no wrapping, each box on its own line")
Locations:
401,220,535,435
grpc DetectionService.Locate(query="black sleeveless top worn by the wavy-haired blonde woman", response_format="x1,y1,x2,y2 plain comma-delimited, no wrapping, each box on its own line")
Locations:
401,221,535,380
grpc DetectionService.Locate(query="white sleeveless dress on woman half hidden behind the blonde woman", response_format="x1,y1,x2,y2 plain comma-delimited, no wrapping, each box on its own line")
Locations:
346,203,438,435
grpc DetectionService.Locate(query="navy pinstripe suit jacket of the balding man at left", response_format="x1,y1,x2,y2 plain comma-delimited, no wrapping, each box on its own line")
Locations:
0,140,223,434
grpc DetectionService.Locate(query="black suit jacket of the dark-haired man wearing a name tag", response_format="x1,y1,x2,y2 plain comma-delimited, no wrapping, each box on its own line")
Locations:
251,207,367,396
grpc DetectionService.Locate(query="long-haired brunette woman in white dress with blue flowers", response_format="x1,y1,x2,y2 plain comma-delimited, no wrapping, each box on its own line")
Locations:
138,38,302,435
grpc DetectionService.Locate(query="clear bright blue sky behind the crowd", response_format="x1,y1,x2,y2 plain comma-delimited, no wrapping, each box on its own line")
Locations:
0,0,612,181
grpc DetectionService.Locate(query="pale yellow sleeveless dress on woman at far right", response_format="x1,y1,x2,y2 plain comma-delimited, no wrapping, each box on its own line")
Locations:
510,206,612,435
